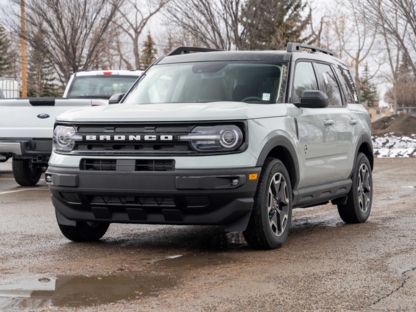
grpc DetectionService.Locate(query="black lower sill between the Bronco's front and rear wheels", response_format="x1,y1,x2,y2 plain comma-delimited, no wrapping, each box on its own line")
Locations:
292,179,352,208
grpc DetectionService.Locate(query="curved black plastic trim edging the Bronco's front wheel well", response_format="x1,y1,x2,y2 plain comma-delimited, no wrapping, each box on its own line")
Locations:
256,135,300,192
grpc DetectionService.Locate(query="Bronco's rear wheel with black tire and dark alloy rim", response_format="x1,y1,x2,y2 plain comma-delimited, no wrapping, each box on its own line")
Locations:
338,153,373,223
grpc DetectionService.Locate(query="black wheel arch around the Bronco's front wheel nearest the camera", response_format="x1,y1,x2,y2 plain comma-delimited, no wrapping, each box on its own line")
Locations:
256,136,300,192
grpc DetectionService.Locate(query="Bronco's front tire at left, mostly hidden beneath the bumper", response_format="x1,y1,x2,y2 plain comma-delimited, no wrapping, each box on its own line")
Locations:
58,221,110,242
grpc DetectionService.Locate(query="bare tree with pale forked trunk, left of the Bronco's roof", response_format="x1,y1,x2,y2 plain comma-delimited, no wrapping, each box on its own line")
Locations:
115,0,170,69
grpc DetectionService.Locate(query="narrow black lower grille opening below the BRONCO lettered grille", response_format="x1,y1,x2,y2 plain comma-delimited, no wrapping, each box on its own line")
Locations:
80,159,175,171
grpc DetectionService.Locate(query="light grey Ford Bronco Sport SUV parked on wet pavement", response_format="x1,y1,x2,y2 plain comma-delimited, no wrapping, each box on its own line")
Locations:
45,43,373,249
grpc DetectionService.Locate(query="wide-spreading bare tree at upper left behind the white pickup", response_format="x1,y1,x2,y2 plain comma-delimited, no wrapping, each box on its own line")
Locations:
3,0,124,85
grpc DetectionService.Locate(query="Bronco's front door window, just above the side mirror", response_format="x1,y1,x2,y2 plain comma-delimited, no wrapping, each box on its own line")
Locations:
293,62,318,103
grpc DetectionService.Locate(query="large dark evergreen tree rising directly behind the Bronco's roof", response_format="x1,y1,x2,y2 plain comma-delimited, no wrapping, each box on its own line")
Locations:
241,0,311,50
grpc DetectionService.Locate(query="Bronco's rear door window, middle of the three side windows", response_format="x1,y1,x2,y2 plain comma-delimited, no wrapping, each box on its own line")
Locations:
316,63,342,106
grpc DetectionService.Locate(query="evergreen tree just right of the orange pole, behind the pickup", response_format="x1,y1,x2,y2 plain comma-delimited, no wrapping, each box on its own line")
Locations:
27,32,59,97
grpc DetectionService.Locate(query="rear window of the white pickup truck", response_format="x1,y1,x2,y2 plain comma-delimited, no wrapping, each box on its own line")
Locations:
67,75,138,99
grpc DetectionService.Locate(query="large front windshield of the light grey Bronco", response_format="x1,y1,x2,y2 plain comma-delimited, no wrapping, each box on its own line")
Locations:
124,62,283,104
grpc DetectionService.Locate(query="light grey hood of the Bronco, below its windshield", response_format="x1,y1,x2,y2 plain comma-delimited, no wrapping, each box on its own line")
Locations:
56,102,287,122
